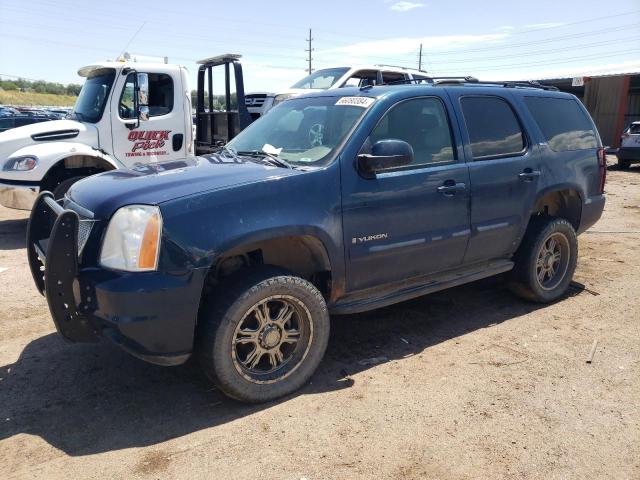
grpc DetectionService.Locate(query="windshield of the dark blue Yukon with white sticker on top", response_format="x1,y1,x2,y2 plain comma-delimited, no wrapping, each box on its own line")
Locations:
227,97,374,166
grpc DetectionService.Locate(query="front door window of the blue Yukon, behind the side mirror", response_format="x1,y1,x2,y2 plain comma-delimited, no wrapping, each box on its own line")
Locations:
369,97,455,168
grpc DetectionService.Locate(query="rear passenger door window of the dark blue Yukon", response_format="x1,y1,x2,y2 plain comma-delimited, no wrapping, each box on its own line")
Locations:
460,97,526,160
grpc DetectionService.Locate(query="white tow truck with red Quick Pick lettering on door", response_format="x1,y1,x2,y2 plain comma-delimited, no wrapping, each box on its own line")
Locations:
0,54,251,210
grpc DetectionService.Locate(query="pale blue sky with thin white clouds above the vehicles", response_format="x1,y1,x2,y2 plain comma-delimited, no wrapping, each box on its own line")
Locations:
0,0,640,91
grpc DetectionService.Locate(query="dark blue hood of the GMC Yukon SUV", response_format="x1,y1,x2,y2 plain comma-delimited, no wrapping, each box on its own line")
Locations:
67,155,303,219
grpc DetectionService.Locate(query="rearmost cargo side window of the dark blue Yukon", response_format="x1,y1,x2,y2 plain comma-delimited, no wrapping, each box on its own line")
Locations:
524,97,598,152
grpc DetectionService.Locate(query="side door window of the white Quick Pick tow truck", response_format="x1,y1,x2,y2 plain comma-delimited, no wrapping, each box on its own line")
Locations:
118,73,173,120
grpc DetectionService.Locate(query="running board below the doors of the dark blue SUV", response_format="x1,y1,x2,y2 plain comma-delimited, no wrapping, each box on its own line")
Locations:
329,260,514,315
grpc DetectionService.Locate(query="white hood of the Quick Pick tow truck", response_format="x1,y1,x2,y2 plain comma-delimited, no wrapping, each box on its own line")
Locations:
0,120,99,162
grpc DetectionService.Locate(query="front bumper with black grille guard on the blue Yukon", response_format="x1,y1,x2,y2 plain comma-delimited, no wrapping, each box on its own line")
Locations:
27,192,207,365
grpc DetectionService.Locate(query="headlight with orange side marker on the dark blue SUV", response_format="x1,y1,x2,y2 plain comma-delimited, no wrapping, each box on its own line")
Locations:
100,205,162,272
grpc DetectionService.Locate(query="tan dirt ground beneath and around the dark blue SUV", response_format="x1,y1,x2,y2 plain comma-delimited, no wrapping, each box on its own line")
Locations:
0,158,640,480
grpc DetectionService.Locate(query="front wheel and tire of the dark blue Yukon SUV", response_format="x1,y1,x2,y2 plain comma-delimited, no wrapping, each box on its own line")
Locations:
196,267,330,403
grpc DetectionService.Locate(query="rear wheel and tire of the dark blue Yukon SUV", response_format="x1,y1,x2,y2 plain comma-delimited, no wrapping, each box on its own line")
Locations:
509,216,578,303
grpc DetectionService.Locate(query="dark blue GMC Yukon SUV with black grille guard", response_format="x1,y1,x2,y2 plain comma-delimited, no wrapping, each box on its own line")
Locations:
28,81,606,402
